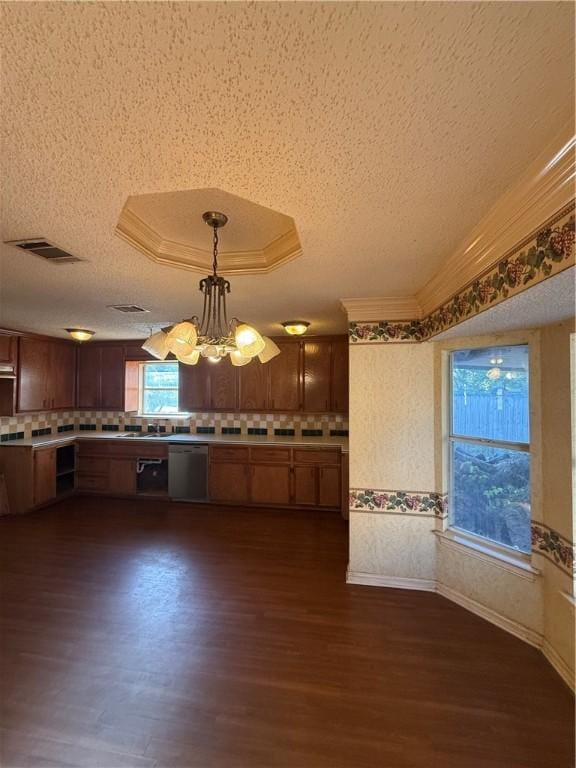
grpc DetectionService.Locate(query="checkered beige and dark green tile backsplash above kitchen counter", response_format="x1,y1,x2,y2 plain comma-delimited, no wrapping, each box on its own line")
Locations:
0,411,348,442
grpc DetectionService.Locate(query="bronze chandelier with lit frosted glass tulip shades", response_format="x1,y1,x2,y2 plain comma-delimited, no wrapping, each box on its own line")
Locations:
142,211,280,366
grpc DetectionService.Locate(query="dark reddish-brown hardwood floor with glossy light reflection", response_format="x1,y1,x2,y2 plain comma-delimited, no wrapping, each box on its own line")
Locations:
0,498,574,768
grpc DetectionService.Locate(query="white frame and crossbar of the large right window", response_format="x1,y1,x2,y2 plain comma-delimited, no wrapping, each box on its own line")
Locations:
446,340,534,563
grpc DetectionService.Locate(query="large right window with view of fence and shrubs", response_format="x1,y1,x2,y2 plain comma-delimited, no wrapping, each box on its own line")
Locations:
450,345,530,553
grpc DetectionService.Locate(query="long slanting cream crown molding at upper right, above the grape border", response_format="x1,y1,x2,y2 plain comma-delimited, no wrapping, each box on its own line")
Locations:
415,124,576,315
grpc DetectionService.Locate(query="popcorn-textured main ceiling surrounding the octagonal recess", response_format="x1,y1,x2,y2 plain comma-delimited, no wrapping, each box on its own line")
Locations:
0,2,574,338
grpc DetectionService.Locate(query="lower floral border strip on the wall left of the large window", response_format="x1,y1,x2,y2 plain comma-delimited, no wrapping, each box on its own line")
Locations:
350,488,447,517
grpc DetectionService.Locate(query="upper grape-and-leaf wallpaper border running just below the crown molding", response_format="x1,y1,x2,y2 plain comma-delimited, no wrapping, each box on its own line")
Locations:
349,203,575,344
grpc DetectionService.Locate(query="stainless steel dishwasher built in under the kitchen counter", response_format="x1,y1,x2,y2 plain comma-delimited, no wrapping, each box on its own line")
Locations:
168,443,208,501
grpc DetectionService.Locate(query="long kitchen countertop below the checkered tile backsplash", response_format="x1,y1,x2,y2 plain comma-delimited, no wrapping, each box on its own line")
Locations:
0,430,348,453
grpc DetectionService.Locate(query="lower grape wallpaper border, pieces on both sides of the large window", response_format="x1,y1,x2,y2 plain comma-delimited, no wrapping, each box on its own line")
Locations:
349,488,575,576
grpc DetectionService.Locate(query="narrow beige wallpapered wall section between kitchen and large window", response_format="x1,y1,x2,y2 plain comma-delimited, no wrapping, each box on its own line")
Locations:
349,344,436,580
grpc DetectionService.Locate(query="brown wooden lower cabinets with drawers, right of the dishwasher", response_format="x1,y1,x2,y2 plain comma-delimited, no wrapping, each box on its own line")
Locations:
208,445,341,509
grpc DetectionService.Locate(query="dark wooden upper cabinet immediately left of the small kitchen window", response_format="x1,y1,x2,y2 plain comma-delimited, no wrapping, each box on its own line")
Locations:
78,344,125,411
